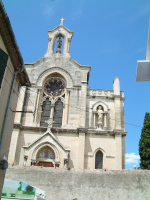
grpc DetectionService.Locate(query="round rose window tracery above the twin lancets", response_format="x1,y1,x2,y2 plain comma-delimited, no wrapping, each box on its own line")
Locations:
44,77,66,97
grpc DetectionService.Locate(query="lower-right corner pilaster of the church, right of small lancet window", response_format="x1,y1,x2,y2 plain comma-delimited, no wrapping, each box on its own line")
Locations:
115,133,122,170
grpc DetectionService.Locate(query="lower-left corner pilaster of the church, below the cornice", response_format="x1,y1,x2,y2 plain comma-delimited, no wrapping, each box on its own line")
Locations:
8,128,20,165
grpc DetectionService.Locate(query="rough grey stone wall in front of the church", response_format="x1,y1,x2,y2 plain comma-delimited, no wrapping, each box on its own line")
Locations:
6,166,150,200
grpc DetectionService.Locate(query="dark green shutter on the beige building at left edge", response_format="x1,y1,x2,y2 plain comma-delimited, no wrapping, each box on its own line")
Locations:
0,48,8,88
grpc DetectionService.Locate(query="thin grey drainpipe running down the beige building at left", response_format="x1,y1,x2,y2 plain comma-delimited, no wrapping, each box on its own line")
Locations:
0,66,24,168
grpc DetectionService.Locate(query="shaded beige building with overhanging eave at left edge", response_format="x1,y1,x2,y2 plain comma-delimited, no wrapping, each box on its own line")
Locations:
0,0,30,196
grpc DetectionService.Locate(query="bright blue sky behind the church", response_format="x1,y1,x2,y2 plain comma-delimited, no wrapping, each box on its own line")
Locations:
3,0,150,169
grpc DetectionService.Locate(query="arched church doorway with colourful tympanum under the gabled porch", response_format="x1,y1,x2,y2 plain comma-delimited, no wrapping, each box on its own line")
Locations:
37,146,55,167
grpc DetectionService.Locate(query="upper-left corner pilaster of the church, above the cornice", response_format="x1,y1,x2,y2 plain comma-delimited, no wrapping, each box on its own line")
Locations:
14,86,26,123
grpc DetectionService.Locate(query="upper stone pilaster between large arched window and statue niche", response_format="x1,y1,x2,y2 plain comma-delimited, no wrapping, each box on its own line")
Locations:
79,81,87,127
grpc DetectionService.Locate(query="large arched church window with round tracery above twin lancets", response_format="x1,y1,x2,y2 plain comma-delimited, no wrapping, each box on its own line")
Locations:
40,74,66,127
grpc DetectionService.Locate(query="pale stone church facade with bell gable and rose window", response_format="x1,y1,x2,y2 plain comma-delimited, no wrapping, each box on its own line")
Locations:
9,19,126,170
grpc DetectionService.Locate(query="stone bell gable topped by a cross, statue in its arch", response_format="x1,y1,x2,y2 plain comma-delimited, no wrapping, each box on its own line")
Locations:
45,18,73,57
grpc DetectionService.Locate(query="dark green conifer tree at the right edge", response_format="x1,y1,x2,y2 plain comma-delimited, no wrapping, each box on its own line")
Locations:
139,112,150,169
